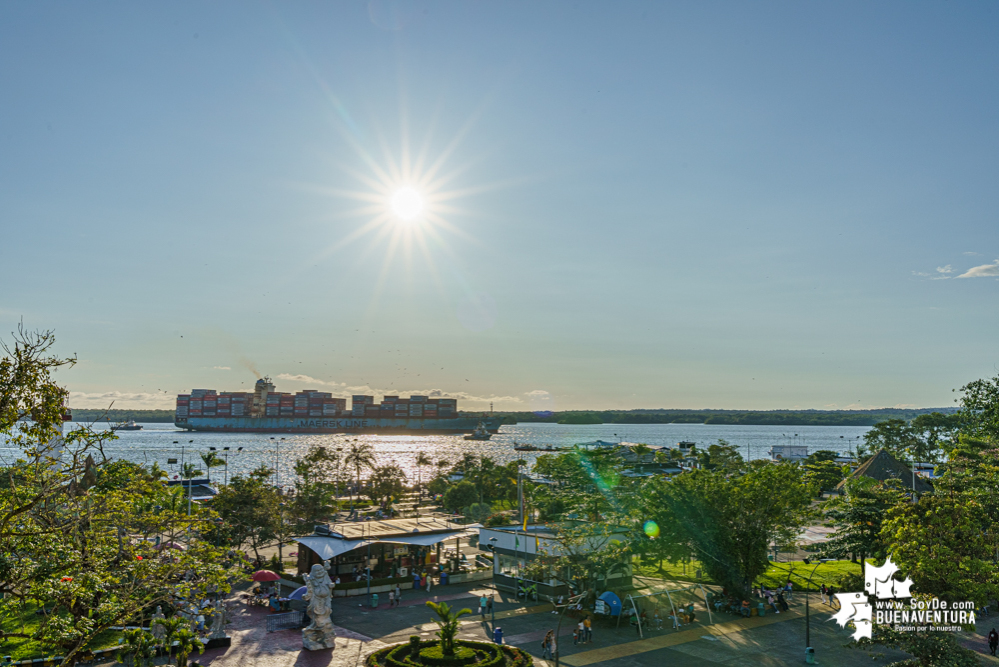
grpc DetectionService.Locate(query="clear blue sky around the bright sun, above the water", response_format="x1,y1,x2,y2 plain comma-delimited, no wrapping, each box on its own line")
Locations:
0,0,999,409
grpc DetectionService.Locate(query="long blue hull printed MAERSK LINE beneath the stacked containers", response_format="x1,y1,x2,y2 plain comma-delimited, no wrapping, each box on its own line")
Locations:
174,417,502,435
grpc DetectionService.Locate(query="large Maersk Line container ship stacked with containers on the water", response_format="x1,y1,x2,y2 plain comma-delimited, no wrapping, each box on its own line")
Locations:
174,378,502,435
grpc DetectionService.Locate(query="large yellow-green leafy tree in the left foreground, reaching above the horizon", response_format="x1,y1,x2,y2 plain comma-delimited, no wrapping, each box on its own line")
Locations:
0,331,235,665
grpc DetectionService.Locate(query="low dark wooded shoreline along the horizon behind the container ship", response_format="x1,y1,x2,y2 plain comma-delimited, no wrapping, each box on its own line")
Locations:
66,407,957,426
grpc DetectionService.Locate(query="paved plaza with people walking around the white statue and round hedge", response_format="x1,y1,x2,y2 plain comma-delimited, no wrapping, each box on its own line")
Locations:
184,582,999,667
